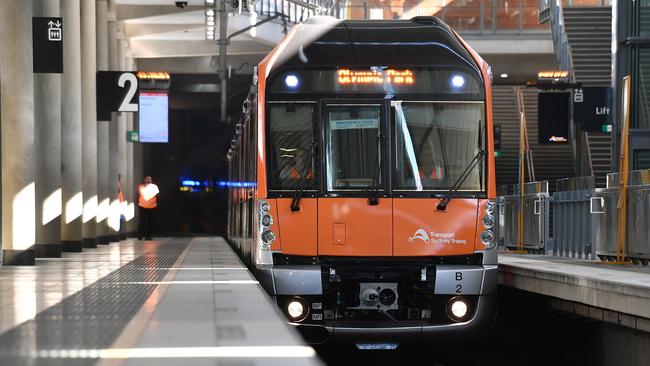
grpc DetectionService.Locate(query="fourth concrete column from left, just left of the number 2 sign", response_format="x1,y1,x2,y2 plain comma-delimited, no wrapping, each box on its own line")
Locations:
81,0,98,248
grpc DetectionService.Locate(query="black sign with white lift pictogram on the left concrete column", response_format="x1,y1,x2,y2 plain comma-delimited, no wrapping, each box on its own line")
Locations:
32,17,63,74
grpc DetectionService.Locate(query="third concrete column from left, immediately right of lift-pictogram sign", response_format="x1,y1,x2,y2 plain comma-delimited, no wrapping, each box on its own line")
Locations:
61,0,83,252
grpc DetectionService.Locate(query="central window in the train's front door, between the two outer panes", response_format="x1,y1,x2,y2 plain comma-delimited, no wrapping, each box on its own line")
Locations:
325,105,383,191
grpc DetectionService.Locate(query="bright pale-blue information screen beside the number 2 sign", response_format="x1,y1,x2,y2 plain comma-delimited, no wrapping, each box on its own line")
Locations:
140,91,169,143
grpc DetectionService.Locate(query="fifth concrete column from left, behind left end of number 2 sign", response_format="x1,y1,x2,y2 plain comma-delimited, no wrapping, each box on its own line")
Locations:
95,0,110,244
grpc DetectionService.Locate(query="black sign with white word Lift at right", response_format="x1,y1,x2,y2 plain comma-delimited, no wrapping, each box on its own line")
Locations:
573,86,612,132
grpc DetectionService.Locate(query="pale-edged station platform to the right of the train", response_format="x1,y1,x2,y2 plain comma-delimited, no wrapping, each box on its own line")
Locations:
499,253,650,332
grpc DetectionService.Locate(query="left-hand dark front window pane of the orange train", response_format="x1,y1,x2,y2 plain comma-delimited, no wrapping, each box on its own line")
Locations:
268,103,317,190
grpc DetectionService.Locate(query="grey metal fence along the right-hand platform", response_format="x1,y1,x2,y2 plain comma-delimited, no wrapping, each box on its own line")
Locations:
498,170,650,264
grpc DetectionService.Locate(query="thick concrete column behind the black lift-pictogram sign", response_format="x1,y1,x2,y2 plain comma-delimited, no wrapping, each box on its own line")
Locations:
34,0,61,258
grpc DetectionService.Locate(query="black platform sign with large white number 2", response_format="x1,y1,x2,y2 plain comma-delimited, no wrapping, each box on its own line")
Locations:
97,71,138,121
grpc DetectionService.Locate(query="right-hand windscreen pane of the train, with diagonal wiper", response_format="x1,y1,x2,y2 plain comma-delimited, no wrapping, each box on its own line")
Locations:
393,101,485,191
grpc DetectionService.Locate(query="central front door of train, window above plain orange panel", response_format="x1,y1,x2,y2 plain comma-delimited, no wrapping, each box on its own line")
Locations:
318,101,393,256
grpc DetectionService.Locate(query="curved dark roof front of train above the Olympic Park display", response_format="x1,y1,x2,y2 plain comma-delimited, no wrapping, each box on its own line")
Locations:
263,17,481,78
